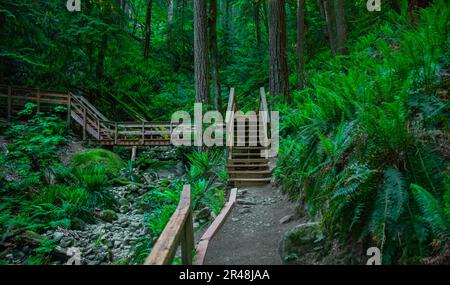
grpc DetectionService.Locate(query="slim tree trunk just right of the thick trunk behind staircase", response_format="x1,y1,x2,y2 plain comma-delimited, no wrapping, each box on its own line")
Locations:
297,0,306,89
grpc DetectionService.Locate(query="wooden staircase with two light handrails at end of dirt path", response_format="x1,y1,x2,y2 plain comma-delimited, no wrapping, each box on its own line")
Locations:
228,89,272,186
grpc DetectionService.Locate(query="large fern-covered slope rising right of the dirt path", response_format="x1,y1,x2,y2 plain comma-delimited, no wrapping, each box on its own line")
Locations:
275,1,450,264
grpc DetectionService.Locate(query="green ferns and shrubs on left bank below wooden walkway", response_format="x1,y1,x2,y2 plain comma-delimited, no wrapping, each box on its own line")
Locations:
0,104,123,264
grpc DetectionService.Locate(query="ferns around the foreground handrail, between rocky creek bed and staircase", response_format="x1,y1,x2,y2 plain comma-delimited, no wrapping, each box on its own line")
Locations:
132,150,227,263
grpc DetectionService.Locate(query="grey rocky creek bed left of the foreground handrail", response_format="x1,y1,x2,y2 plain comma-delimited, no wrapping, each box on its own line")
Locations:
5,185,148,265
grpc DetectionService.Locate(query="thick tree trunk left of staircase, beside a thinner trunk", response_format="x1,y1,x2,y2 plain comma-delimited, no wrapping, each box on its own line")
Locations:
194,0,210,104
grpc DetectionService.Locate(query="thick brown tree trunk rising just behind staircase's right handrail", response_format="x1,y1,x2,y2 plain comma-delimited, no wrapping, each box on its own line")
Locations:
269,0,290,102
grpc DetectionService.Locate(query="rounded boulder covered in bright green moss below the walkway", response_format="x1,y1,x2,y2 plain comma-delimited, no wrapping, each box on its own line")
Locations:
72,148,125,177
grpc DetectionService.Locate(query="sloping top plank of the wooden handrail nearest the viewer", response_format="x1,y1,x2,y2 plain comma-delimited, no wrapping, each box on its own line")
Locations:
144,185,192,265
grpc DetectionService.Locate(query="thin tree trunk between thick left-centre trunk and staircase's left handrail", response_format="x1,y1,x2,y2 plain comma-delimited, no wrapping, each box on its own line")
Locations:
209,0,222,111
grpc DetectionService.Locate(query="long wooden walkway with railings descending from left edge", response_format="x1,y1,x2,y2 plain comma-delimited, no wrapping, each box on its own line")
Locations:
0,85,178,146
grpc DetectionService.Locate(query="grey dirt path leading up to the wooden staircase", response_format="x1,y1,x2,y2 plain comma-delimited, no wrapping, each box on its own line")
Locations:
205,184,298,265
